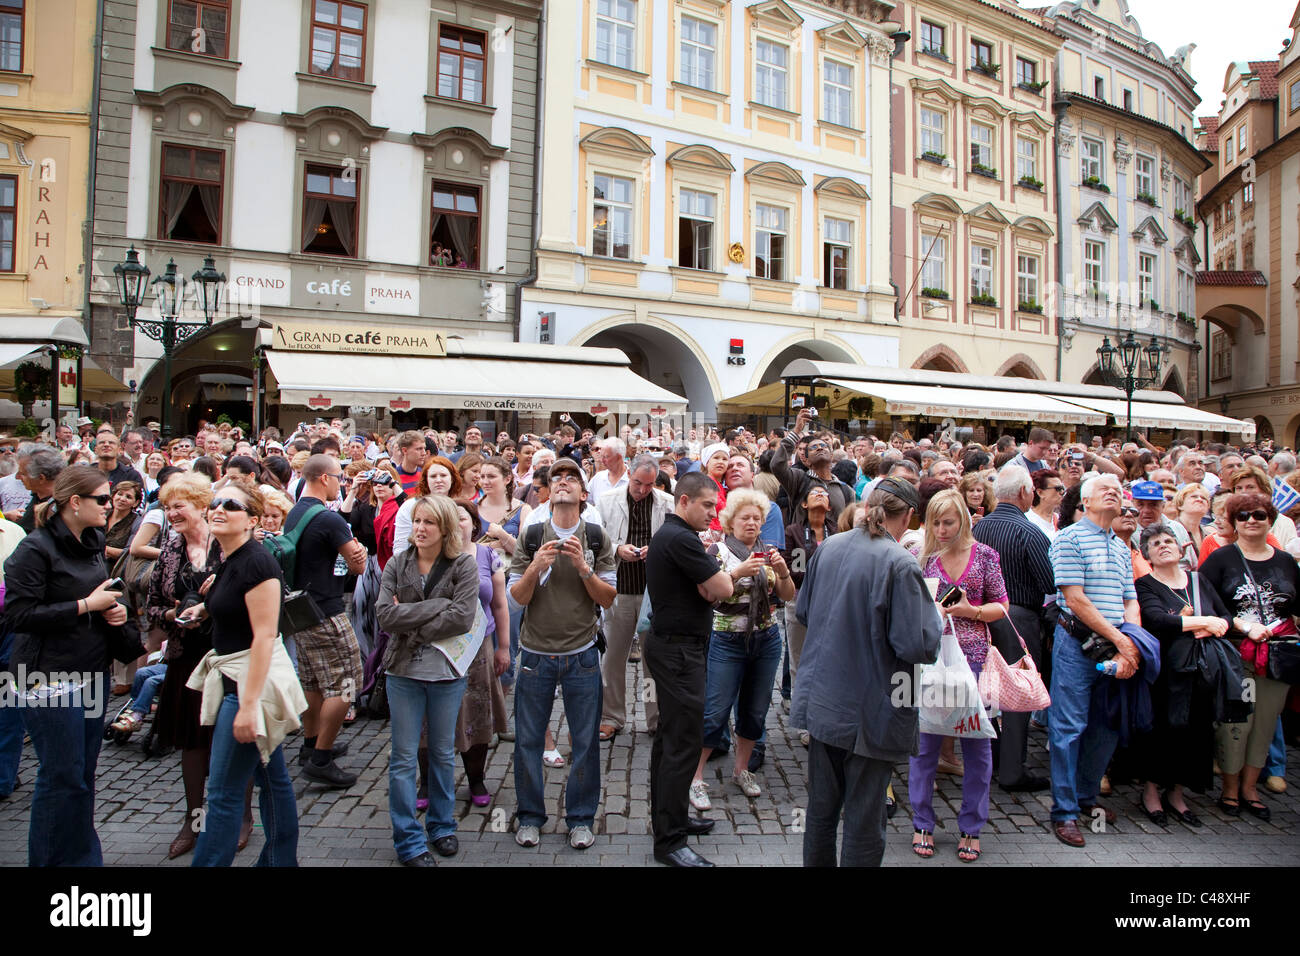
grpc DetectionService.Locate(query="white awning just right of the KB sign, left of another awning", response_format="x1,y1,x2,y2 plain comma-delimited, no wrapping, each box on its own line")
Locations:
823,378,1106,425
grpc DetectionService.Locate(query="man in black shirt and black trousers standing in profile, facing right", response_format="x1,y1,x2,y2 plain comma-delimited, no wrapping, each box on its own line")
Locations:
642,472,733,866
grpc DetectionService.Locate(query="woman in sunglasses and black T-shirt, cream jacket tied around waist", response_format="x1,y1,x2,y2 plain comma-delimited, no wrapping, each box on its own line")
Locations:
182,483,297,866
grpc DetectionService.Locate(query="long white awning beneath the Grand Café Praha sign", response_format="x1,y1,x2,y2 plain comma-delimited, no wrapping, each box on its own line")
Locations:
267,343,686,416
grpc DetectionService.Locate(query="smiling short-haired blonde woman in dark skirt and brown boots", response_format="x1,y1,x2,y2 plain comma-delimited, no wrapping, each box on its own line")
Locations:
144,472,252,860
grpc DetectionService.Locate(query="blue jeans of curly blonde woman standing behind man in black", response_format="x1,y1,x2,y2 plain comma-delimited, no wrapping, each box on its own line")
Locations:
705,624,781,748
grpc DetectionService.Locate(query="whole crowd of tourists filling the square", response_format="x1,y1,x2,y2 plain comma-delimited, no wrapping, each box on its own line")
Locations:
0,408,1300,866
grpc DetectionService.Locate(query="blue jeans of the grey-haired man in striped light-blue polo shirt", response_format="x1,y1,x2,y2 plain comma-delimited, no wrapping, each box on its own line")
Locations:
1048,627,1119,821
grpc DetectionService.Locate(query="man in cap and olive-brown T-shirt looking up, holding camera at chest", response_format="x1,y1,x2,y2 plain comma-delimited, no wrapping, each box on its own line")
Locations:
508,458,618,849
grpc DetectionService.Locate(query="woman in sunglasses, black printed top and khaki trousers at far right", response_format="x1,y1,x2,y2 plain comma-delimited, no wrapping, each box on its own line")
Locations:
1200,493,1300,821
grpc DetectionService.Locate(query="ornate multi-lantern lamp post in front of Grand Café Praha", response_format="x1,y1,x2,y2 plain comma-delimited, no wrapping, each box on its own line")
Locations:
113,245,226,438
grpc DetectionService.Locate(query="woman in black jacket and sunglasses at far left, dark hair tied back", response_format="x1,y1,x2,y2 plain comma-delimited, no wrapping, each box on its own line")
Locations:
5,464,144,866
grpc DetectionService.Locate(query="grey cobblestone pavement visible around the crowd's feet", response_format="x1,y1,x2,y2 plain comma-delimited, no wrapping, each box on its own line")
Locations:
0,665,1300,866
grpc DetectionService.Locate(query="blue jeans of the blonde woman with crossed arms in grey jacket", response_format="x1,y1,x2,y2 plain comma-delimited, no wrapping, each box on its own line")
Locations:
389,674,467,860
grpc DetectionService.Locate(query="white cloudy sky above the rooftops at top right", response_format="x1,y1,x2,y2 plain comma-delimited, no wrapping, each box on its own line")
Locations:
1128,0,1296,116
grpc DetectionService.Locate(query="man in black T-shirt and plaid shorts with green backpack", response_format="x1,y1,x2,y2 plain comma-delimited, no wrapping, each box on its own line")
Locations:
285,455,367,787
